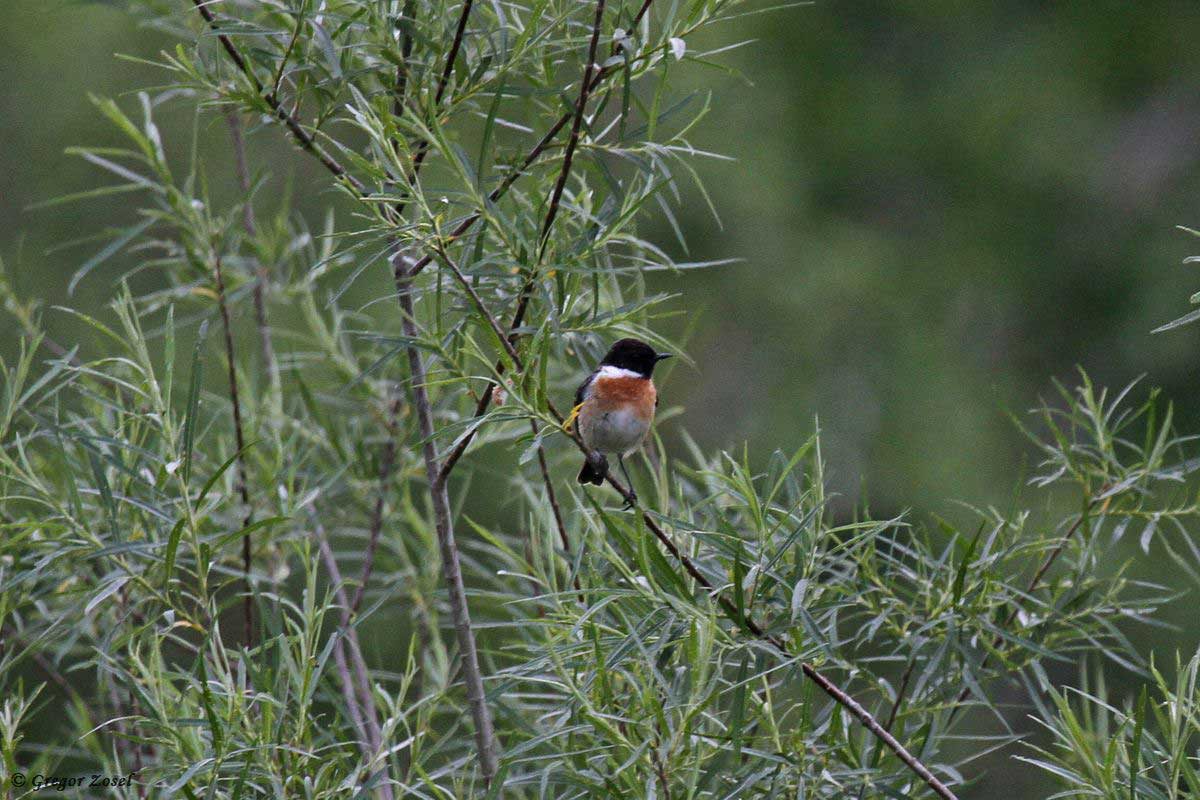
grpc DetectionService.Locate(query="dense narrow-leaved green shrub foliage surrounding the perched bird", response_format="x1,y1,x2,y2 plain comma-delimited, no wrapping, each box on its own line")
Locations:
0,0,1200,798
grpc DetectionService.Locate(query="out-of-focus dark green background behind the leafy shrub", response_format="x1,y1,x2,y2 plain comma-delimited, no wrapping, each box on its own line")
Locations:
0,0,1200,796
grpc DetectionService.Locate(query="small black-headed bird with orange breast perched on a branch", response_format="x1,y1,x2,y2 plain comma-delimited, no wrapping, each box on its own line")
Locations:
571,338,672,506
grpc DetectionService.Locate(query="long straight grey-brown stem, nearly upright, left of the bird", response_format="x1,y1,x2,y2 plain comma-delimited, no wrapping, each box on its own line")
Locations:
395,253,499,786
